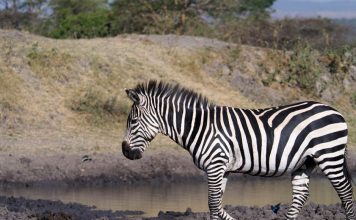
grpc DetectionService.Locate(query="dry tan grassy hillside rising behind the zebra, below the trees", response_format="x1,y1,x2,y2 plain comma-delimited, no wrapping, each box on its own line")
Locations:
0,30,356,155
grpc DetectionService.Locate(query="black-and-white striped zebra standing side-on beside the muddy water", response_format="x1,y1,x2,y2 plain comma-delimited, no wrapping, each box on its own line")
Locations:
122,80,355,220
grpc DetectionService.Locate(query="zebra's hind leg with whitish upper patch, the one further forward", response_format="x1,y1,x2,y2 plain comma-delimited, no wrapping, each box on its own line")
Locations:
286,160,315,219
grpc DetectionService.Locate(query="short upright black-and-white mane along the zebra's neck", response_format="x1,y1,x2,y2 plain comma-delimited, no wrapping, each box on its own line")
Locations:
134,80,213,107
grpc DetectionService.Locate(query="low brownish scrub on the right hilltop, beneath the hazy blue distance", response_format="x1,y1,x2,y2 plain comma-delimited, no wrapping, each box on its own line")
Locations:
211,18,352,51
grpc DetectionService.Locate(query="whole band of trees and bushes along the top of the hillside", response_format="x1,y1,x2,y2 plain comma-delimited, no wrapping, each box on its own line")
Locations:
0,0,354,49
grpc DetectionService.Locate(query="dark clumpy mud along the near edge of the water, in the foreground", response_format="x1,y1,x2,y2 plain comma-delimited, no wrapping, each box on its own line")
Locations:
0,196,352,220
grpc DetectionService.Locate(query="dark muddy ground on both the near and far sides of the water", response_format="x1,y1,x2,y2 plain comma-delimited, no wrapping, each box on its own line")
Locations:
0,150,356,220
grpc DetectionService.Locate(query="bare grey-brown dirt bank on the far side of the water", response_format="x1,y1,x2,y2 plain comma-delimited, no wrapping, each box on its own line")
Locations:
0,149,356,186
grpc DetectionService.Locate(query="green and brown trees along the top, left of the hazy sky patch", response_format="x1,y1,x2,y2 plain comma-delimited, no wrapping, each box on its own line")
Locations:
0,0,275,38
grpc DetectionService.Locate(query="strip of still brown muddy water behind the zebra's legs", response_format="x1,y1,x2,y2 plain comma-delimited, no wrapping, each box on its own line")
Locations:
0,178,352,216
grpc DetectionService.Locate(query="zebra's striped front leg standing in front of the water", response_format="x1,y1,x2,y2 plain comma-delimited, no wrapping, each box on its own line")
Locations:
207,167,234,220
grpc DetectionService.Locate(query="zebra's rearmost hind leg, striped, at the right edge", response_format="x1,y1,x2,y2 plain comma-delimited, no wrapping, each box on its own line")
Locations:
316,151,356,220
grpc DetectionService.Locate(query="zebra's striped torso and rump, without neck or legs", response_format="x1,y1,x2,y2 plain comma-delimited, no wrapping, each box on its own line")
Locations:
217,102,347,176
